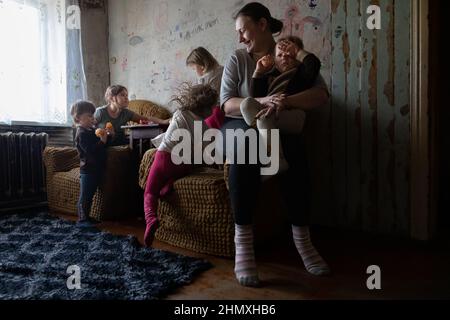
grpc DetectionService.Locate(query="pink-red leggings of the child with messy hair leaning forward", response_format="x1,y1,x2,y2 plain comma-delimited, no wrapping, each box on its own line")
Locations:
144,151,191,247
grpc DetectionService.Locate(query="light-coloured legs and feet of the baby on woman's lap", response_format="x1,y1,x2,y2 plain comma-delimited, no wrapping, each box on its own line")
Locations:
241,98,289,172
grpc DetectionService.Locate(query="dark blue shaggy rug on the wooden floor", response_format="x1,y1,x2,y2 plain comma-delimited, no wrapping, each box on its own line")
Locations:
0,213,211,300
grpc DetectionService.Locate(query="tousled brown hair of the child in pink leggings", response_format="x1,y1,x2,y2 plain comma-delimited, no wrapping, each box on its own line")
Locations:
171,82,219,118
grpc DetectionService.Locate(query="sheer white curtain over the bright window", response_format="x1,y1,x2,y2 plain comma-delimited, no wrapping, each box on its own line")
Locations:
0,0,86,125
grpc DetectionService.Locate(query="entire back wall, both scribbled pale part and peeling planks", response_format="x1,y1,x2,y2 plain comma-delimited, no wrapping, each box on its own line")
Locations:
109,0,411,236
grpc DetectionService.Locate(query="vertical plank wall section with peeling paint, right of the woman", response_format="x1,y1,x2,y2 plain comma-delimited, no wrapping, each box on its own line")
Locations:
306,0,410,236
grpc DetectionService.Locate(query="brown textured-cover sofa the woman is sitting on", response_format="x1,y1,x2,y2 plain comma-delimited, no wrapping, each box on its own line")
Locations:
139,149,286,257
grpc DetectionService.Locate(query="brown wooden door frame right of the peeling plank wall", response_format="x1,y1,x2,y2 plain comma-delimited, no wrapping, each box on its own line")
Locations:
410,0,436,240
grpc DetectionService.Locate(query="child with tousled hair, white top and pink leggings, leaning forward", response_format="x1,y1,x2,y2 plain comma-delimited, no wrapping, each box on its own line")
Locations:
144,84,224,247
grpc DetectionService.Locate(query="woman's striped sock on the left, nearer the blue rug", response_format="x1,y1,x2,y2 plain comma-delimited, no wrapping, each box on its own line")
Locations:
234,225,259,287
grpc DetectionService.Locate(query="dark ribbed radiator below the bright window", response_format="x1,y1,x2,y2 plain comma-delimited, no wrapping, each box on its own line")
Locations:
0,132,48,202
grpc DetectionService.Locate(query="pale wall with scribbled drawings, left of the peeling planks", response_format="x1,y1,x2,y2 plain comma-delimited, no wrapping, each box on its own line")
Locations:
109,0,331,109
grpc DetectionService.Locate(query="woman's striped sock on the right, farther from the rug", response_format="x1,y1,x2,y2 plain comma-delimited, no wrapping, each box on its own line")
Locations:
292,226,330,276
